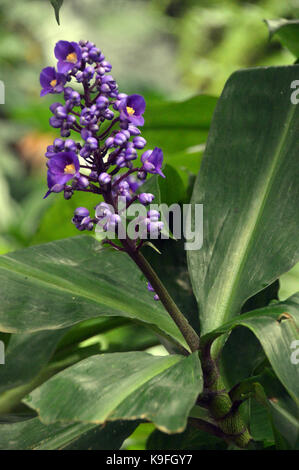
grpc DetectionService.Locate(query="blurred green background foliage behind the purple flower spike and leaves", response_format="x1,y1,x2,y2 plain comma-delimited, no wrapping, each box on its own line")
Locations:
0,0,299,449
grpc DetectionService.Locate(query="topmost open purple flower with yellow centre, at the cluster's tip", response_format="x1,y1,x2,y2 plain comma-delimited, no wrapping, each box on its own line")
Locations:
54,41,82,74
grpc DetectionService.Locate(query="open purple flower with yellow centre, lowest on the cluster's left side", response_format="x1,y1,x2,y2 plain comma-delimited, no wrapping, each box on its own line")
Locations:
45,152,80,197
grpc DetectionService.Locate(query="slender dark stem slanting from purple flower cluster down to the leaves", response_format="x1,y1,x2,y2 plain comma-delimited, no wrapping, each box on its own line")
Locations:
122,240,199,352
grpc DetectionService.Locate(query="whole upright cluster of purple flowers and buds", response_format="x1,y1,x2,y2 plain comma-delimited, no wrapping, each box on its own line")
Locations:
40,41,164,298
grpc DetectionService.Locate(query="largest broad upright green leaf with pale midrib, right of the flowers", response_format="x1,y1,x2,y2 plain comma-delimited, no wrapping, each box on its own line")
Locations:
188,66,299,334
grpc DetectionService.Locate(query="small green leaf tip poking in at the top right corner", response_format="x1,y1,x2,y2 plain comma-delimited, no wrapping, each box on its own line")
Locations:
265,19,299,58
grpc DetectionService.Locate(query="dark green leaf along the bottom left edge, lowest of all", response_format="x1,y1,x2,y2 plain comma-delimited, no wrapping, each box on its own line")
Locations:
0,418,138,450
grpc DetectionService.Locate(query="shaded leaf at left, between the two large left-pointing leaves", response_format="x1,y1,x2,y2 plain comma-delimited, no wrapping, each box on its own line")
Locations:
0,317,165,414
